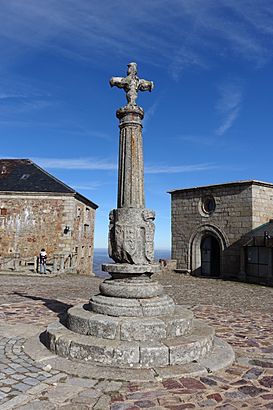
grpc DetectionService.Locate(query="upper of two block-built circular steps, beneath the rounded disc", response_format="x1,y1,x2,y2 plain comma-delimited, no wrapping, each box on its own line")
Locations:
66,304,193,341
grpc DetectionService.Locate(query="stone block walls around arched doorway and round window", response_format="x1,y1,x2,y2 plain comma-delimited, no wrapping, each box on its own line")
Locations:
170,181,273,278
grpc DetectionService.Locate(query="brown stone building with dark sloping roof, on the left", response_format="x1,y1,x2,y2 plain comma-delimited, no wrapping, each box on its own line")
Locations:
0,159,97,274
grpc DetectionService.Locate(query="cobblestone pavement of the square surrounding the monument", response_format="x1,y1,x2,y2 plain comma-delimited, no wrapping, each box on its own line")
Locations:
0,273,273,410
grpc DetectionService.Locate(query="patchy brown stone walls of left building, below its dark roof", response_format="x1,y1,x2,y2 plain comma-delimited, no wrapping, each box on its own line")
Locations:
0,193,95,274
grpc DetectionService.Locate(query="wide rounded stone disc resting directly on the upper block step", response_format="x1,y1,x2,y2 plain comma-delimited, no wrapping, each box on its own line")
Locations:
90,295,175,317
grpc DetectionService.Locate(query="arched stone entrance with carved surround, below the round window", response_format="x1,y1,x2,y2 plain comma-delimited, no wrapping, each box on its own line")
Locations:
188,224,229,276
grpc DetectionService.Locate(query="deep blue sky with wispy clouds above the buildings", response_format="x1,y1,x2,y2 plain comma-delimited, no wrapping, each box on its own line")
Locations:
0,0,273,248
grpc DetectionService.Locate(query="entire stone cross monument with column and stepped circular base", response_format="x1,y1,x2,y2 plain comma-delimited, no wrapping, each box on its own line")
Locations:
46,63,234,377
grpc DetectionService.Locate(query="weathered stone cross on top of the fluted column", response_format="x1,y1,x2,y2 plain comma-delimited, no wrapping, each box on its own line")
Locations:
110,63,154,106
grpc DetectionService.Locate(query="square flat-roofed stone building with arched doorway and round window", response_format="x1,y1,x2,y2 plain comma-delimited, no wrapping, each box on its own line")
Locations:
169,181,273,284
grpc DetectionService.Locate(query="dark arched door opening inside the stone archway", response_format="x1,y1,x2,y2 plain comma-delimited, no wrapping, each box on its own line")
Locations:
200,234,221,277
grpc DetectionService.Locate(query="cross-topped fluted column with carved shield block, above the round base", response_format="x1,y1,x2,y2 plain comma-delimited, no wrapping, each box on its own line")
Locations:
104,63,157,264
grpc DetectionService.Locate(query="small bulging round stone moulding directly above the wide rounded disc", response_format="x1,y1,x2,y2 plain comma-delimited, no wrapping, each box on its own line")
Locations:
100,277,163,299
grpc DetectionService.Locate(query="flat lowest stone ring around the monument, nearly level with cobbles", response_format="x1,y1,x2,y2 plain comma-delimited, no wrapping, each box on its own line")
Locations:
24,334,235,382
